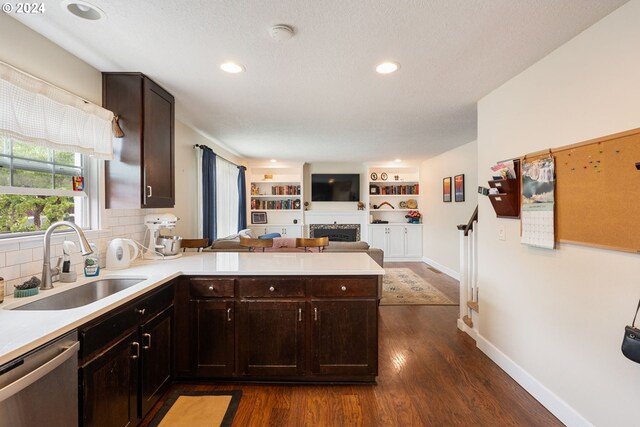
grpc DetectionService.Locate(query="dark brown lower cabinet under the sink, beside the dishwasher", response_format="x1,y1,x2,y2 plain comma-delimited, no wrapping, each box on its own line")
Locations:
78,284,174,427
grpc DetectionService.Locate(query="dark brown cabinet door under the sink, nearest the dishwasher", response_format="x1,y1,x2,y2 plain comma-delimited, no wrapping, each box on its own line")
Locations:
80,330,141,427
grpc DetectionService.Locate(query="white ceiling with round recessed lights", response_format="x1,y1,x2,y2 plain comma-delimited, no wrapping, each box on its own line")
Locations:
13,0,627,162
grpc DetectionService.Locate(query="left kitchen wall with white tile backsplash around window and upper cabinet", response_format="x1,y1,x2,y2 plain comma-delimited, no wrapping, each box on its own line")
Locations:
0,13,241,294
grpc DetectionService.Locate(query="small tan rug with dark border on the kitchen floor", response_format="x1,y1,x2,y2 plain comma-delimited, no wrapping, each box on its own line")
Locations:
149,389,242,427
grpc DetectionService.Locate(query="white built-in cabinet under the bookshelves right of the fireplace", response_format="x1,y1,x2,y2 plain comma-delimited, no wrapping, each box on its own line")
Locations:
369,224,422,261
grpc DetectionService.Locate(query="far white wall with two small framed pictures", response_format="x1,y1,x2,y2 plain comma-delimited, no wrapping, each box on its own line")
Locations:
420,141,478,278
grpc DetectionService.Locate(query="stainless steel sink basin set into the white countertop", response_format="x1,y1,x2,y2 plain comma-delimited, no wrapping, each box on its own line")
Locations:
13,278,145,310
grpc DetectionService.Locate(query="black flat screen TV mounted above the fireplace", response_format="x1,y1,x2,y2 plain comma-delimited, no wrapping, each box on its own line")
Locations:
311,173,360,202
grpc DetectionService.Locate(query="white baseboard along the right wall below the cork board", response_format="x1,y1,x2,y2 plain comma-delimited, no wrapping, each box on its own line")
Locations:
478,334,593,427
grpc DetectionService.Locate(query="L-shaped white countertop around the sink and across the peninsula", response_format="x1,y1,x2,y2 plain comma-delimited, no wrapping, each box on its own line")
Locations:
0,252,384,365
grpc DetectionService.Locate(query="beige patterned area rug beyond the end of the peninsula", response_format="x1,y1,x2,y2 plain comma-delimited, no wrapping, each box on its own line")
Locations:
380,268,458,305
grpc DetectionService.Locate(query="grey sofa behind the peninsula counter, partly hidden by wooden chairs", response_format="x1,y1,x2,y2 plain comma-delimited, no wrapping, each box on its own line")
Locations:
204,237,384,267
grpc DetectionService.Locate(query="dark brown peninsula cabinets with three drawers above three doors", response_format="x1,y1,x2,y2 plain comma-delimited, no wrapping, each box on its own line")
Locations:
175,276,379,382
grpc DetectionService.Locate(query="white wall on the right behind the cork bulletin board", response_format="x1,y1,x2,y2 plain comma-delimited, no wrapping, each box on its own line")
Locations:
478,0,640,426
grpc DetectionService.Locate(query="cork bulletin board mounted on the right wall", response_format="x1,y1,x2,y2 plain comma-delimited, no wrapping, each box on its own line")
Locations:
526,129,640,254
